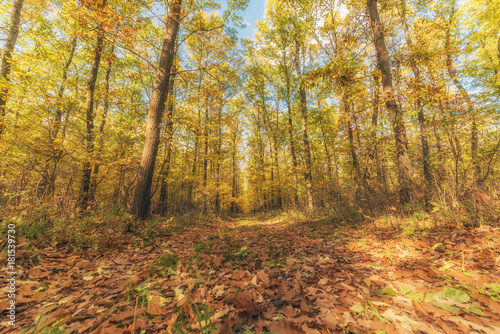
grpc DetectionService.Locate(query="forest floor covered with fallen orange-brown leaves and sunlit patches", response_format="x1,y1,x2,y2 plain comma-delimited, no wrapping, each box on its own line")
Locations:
0,215,500,334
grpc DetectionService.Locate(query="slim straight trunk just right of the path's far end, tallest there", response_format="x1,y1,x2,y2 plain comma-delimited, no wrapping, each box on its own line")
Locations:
295,41,314,210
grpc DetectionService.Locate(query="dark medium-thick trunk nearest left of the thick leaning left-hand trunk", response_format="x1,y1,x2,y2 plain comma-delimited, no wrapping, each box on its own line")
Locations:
78,26,105,209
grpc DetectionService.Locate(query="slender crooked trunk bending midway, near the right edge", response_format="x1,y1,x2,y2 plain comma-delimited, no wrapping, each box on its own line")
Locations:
445,1,481,182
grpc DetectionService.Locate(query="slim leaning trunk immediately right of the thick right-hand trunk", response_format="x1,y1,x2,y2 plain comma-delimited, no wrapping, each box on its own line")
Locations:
401,0,432,201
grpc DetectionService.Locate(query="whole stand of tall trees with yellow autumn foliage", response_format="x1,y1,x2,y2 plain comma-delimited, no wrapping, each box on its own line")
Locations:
0,0,500,219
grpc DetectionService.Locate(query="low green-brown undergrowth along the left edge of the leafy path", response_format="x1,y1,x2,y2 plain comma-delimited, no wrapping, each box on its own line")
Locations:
0,204,215,250
